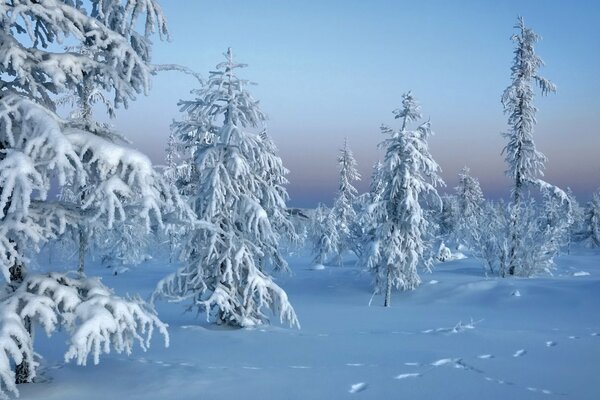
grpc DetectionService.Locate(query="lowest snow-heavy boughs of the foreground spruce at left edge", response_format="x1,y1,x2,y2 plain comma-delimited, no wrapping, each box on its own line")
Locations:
0,273,169,398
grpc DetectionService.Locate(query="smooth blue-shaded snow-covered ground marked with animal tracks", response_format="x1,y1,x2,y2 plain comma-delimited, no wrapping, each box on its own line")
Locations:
20,249,600,400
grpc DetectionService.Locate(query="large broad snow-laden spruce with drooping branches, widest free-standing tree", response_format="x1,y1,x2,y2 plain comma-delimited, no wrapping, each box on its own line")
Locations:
153,49,298,327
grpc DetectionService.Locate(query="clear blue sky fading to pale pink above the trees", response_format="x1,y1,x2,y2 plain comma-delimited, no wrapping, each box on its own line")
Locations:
115,0,600,207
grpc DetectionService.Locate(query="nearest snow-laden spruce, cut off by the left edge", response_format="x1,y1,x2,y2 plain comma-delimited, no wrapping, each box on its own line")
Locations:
0,0,185,395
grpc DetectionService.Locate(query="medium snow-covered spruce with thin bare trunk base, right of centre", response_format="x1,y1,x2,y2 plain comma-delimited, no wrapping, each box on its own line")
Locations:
365,92,443,307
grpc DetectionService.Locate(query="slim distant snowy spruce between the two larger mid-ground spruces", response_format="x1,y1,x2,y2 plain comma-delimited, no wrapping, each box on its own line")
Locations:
332,139,360,265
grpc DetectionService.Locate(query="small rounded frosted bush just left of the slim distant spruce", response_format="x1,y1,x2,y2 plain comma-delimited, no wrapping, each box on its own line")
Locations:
311,204,339,265
